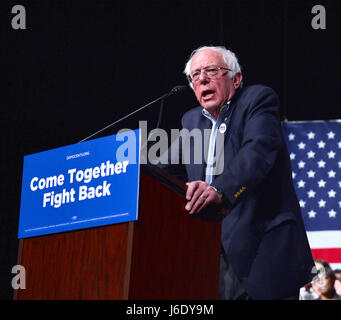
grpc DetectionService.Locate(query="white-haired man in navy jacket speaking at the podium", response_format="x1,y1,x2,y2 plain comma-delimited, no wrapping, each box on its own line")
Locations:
162,47,314,299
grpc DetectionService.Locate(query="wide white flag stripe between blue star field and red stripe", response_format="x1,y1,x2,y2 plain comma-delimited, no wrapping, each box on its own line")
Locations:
307,230,341,249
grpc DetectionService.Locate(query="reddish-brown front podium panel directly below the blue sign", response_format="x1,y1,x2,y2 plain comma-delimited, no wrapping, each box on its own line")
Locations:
16,222,132,299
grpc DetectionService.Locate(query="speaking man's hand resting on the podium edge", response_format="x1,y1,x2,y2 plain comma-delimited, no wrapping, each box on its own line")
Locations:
185,180,222,214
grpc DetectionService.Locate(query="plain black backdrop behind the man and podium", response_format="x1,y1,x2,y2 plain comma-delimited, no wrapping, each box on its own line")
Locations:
0,0,341,299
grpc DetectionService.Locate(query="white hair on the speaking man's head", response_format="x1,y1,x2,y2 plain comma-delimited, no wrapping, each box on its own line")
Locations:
184,46,241,89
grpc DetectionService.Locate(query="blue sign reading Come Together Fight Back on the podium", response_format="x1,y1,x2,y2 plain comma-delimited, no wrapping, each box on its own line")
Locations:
18,129,140,238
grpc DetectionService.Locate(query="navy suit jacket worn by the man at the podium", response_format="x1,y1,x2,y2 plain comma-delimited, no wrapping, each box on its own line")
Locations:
162,85,314,299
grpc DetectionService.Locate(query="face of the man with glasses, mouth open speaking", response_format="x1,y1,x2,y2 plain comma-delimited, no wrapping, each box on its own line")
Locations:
190,49,241,114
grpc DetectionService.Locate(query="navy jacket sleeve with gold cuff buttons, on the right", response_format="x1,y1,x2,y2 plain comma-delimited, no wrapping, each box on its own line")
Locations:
212,88,284,208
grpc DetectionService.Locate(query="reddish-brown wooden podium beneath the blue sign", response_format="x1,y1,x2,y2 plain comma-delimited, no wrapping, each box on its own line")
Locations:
14,165,221,300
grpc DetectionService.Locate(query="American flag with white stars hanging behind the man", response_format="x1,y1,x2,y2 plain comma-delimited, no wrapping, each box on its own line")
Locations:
283,120,341,269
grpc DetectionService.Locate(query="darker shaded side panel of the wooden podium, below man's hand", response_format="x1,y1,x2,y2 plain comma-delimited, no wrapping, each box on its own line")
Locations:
129,172,220,299
